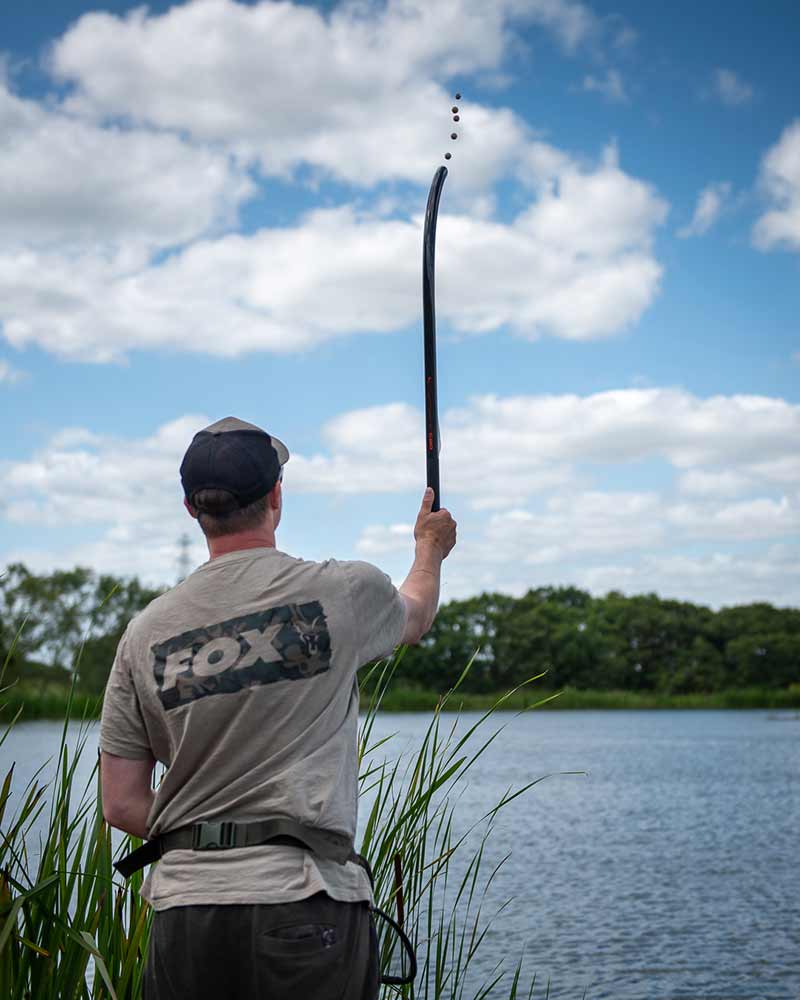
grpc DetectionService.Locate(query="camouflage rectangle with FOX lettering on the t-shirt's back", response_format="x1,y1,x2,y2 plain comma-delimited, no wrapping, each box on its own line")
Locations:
151,601,331,711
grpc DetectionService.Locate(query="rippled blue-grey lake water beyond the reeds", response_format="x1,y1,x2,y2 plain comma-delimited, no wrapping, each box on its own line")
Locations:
0,711,800,1000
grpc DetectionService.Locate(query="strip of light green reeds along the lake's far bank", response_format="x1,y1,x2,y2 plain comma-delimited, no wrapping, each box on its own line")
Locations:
0,684,800,724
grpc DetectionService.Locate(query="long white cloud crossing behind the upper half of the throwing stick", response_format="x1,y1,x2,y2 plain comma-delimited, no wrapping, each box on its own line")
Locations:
0,150,666,361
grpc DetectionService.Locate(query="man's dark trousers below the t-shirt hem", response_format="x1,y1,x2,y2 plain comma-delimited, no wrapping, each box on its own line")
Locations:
143,893,379,1000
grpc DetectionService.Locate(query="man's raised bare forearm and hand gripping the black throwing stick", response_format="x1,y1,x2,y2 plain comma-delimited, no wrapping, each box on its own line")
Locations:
399,487,456,644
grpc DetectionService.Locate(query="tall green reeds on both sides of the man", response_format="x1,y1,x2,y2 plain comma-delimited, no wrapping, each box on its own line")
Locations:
0,654,574,1000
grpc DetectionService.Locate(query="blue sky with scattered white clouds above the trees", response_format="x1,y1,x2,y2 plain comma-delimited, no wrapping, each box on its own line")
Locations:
0,0,800,607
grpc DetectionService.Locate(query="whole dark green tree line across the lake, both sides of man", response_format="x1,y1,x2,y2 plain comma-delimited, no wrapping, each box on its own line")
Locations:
0,563,800,694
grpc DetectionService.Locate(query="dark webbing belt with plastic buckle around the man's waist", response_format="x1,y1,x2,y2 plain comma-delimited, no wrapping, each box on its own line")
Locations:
114,816,372,882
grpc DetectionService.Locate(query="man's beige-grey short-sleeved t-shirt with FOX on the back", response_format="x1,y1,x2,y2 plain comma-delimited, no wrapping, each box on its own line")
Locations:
100,548,405,910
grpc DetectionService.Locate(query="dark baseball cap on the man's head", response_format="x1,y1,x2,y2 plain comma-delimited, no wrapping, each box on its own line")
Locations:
181,417,289,513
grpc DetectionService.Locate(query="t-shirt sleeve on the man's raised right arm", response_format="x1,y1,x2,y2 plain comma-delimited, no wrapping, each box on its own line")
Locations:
342,561,406,665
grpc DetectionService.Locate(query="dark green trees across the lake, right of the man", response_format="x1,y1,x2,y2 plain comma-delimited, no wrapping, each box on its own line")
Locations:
400,587,800,694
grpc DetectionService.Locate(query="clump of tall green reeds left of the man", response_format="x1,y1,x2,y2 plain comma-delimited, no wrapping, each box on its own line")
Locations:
0,676,149,1000
